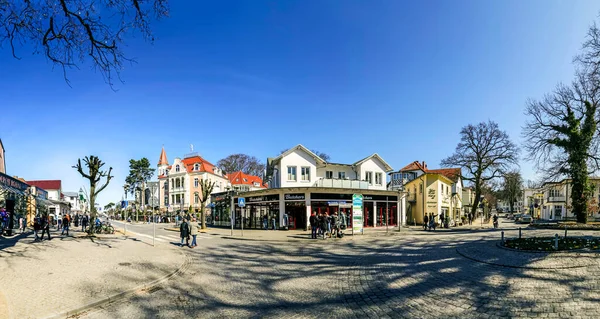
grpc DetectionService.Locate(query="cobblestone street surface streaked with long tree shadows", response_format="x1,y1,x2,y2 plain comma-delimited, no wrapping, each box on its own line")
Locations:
79,221,600,319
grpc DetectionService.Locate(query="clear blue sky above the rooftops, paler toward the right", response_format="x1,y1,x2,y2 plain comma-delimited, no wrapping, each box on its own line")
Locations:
0,0,600,204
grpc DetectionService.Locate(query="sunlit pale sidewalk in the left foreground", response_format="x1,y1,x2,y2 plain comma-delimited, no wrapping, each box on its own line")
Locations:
0,232,186,318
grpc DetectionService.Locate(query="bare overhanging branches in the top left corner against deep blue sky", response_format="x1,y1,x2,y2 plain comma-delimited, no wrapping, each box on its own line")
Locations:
0,0,169,87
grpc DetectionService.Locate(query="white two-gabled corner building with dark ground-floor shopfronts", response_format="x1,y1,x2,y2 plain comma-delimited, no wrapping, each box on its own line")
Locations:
213,144,404,230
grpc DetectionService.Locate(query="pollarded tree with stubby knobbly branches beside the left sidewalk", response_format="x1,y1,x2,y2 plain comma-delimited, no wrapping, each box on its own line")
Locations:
73,155,113,234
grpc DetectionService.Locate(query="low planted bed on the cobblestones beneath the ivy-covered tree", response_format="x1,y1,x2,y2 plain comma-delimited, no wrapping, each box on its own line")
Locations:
504,237,600,251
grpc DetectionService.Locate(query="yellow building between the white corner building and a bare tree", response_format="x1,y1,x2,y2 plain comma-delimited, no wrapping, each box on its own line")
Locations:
404,173,460,224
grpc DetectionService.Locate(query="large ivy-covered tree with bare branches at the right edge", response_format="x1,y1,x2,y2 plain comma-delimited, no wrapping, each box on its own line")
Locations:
522,24,600,223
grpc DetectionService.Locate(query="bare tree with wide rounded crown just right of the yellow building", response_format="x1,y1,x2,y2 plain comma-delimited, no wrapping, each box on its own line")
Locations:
441,121,519,216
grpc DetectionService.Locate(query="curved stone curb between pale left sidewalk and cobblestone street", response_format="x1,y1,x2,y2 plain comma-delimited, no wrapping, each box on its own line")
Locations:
45,242,191,319
